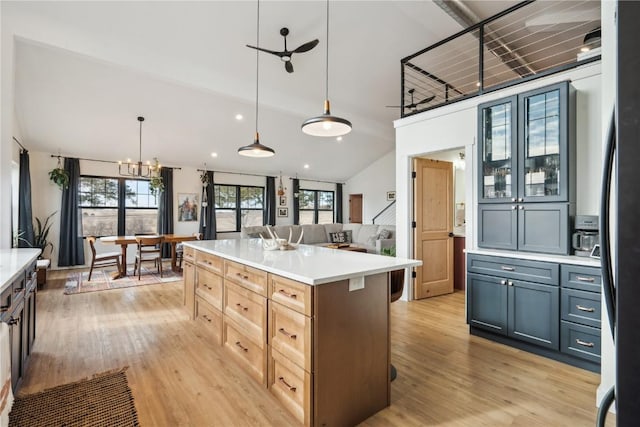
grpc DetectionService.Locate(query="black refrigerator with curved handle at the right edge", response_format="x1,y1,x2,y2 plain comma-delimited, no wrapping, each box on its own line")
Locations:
601,1,640,426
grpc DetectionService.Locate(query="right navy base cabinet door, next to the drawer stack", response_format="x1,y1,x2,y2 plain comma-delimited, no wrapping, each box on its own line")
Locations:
508,281,560,350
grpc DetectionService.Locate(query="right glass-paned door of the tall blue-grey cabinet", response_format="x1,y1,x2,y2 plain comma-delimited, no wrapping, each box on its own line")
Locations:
520,85,567,206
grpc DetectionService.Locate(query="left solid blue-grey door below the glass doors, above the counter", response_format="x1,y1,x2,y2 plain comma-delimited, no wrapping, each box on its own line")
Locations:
478,204,518,250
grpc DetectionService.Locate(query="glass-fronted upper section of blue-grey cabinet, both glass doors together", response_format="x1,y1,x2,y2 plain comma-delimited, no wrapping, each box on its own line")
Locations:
478,82,575,203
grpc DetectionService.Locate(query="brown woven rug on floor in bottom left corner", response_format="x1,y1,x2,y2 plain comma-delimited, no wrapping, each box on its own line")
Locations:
9,368,140,427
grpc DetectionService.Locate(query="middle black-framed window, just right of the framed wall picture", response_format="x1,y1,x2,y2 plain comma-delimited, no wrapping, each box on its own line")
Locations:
213,184,264,233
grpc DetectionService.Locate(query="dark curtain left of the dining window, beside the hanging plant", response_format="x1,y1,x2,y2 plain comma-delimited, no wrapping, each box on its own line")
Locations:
58,159,84,267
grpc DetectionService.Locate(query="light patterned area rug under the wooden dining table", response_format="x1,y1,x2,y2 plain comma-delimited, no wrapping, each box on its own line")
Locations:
64,266,182,295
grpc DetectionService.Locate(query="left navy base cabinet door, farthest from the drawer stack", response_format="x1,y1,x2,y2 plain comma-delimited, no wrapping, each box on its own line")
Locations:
467,273,507,335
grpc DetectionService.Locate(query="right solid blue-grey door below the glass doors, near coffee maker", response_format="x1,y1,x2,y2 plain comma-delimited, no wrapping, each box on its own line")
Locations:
518,203,569,255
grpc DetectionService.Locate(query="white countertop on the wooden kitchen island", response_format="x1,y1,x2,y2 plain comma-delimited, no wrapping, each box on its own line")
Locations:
184,239,422,285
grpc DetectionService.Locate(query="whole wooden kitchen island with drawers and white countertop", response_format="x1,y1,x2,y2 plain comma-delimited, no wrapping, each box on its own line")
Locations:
184,239,421,425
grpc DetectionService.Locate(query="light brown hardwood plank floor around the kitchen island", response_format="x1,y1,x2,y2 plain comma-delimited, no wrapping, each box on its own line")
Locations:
20,271,615,426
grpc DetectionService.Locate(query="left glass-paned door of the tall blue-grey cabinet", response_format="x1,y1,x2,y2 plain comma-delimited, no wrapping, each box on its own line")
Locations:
478,97,518,202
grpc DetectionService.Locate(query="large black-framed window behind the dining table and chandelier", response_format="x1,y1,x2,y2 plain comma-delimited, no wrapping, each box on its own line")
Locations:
78,176,158,236
